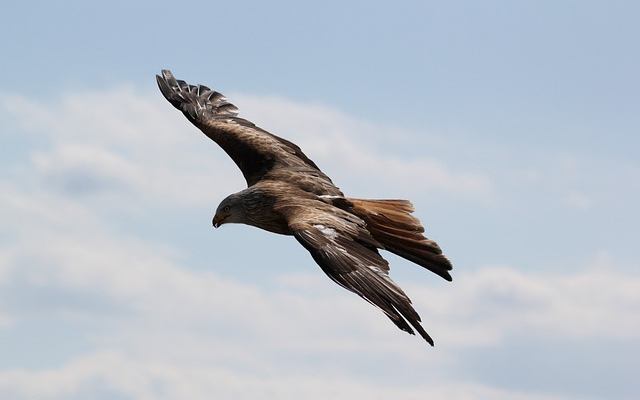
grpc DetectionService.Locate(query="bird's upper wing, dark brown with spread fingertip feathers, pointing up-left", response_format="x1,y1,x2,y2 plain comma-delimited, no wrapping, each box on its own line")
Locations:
156,71,340,195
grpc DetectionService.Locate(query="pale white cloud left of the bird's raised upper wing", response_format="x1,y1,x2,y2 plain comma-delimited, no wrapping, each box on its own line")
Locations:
2,88,242,209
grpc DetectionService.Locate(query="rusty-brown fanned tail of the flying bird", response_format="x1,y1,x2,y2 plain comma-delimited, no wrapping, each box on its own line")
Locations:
347,199,453,281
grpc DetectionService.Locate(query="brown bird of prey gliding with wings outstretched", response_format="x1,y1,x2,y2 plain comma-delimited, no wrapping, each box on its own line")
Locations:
156,70,452,346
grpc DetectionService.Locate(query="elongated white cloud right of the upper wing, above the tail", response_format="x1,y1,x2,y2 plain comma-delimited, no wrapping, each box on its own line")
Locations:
233,96,492,200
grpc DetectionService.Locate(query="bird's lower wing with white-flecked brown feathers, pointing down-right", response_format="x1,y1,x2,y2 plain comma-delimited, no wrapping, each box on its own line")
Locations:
287,205,433,346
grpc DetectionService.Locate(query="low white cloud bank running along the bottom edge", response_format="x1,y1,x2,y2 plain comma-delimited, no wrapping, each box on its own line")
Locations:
0,351,570,400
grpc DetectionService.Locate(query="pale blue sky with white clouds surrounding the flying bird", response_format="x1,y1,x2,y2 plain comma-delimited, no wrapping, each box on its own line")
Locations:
0,0,640,400
